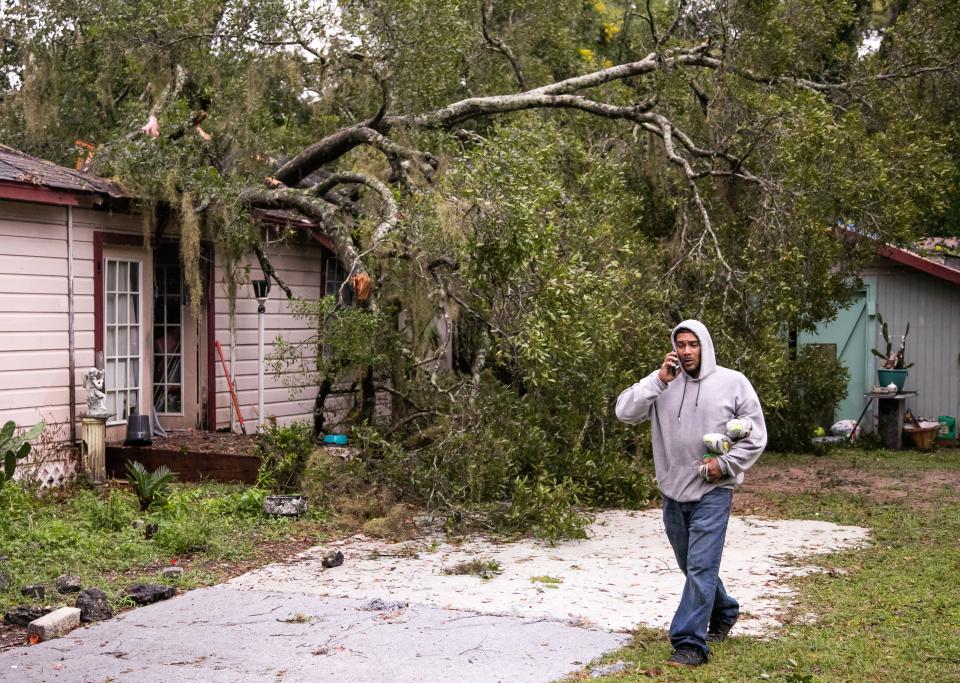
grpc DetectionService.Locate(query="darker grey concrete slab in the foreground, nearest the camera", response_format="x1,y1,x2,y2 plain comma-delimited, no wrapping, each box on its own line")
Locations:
0,585,627,683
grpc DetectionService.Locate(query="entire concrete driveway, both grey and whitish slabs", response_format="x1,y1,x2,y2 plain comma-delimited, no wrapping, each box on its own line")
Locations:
0,511,868,683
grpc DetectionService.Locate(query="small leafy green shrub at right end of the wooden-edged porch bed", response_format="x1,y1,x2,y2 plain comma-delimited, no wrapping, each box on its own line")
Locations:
254,421,313,493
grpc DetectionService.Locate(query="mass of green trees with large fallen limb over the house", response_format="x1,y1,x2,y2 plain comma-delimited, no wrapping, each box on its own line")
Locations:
0,0,960,528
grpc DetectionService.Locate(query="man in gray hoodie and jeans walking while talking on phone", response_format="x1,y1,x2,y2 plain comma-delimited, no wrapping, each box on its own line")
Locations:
617,320,767,666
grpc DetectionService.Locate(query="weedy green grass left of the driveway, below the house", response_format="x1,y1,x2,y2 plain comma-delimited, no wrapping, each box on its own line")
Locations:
0,483,326,648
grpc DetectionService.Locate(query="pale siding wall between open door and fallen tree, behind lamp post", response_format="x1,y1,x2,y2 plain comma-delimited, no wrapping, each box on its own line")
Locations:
215,245,322,428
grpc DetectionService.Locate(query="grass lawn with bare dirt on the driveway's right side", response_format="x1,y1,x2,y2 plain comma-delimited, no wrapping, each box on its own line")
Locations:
591,449,960,683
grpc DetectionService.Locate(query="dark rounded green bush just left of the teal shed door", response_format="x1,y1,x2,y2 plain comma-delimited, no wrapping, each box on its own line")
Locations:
765,346,850,453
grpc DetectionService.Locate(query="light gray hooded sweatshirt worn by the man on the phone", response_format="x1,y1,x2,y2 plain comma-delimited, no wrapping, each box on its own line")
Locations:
617,320,767,502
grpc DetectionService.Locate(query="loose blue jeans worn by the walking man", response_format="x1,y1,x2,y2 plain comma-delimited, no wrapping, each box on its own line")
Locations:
663,488,740,654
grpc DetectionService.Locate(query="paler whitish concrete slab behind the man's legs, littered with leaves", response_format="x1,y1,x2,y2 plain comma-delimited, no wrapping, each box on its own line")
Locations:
230,510,868,635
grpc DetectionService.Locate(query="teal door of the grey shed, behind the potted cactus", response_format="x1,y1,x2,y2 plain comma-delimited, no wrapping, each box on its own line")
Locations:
798,278,876,420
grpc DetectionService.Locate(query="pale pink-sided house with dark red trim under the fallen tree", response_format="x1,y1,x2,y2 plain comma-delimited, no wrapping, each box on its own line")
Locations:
0,145,358,442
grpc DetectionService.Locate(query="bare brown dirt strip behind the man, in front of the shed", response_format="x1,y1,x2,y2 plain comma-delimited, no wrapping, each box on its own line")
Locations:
733,455,960,517
